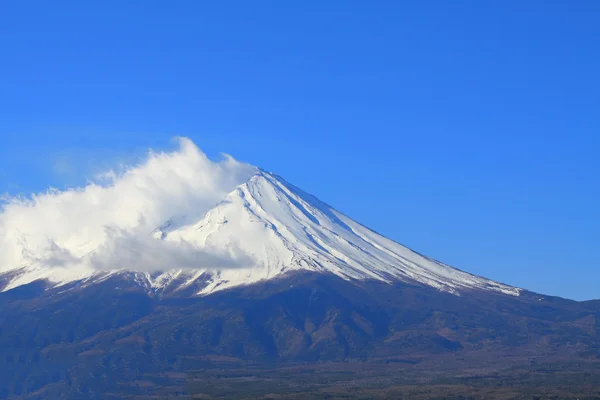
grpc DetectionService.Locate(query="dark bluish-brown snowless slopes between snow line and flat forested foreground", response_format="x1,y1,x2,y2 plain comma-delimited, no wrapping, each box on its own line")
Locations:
0,272,600,398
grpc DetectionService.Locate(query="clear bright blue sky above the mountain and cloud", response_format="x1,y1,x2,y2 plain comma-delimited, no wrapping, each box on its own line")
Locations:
0,0,600,299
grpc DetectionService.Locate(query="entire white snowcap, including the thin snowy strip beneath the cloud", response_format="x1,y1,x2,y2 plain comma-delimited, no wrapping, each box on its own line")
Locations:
0,169,519,296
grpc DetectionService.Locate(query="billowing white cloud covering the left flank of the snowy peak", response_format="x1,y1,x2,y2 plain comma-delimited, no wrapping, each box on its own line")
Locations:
0,138,256,272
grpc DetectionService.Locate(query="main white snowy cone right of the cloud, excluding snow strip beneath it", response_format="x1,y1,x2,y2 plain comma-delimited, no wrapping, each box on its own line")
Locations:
149,170,518,294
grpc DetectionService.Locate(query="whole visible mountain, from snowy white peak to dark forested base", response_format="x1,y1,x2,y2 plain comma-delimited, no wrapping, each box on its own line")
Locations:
0,170,600,399
